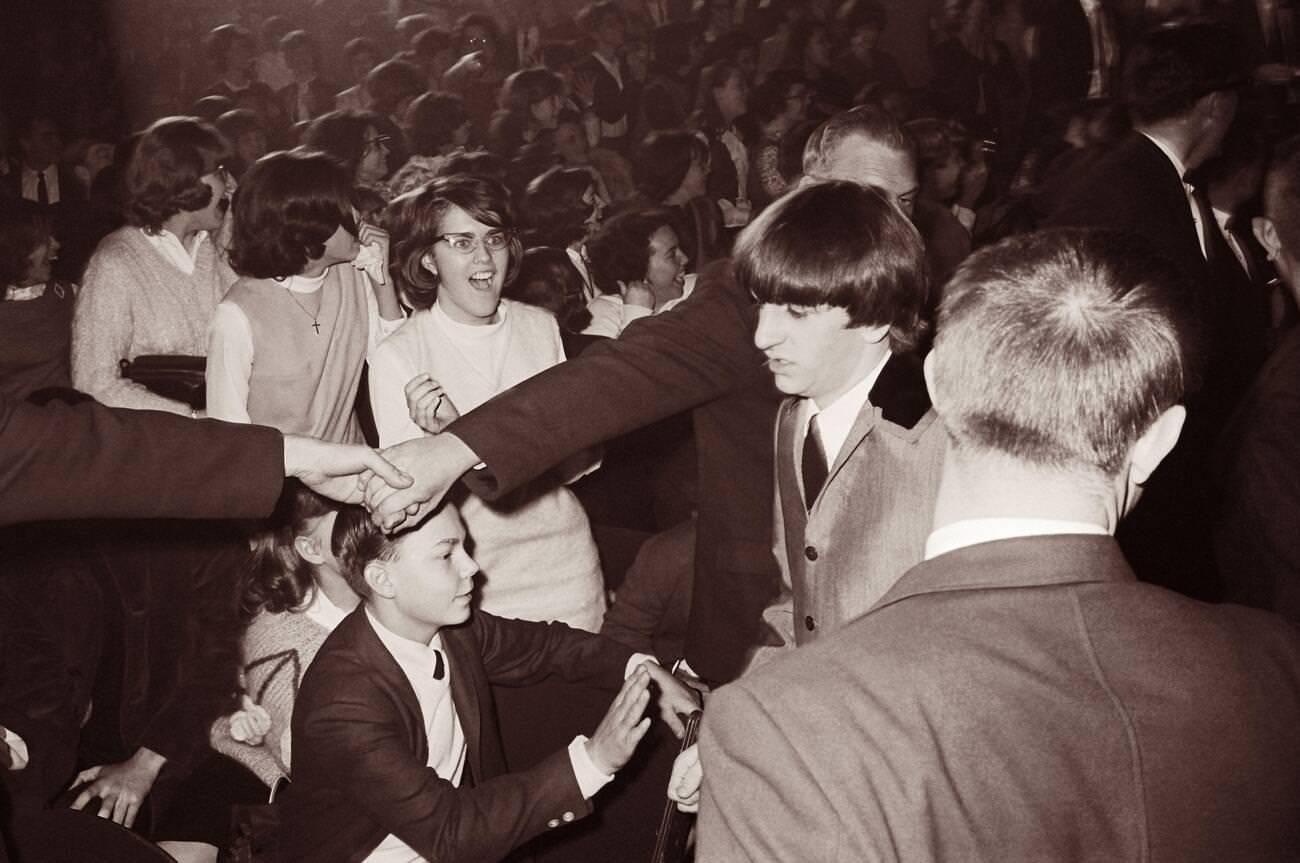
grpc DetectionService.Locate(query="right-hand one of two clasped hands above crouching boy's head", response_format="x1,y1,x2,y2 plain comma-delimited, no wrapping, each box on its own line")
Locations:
365,432,478,532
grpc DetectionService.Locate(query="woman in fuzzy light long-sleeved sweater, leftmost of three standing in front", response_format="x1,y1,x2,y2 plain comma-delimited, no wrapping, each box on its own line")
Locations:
72,117,235,415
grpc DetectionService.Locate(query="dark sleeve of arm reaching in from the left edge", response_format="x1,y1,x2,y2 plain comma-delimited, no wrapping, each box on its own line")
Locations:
0,396,285,524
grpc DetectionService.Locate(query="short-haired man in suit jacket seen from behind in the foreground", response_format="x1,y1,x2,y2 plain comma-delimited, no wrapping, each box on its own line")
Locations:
698,231,1300,863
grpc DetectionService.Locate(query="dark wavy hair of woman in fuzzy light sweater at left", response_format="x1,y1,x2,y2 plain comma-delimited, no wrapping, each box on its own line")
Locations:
125,117,230,234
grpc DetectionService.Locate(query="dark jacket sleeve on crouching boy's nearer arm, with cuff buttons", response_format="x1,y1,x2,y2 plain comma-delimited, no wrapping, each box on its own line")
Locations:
294,656,592,863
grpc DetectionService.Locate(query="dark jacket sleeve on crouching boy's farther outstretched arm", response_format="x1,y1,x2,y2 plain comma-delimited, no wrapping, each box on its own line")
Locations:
472,611,632,689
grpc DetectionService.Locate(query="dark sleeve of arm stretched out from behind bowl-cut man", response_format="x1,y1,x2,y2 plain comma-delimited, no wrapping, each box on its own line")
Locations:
451,261,762,499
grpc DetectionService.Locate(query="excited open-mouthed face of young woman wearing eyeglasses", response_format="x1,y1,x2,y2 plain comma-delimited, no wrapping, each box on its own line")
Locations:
423,205,510,325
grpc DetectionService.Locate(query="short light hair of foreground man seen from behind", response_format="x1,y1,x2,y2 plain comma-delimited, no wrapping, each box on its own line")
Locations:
931,229,1190,477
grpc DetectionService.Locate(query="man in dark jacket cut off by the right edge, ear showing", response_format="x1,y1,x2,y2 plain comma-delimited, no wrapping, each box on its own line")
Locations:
1214,135,1300,623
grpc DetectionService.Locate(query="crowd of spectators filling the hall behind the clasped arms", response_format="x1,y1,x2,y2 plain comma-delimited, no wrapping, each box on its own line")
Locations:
0,0,1300,859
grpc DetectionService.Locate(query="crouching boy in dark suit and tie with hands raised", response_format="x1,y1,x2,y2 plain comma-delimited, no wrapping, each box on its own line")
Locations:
281,504,697,863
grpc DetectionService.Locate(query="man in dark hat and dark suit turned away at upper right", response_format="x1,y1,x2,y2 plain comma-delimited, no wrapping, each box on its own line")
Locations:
1039,23,1242,599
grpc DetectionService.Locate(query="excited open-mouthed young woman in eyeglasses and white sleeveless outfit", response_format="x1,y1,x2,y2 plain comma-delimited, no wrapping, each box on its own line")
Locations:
371,174,605,632
